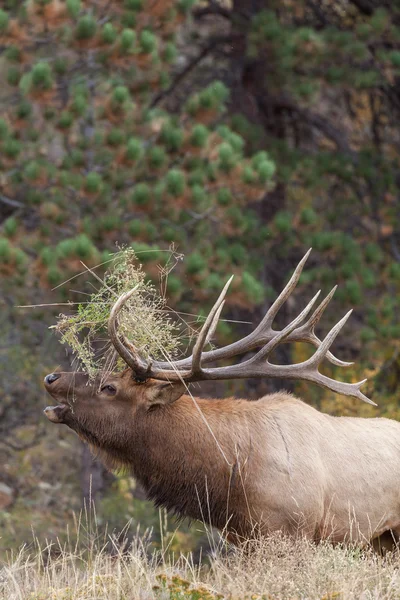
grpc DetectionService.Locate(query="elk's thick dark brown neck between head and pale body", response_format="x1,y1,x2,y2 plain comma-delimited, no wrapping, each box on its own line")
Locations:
126,396,262,531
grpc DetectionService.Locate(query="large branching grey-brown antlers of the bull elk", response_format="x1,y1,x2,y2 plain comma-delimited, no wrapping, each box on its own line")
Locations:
108,249,375,405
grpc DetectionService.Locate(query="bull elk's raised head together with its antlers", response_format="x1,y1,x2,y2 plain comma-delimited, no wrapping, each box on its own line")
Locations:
45,250,374,443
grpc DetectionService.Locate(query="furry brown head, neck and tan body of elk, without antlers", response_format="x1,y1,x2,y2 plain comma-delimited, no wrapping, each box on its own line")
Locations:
46,370,400,542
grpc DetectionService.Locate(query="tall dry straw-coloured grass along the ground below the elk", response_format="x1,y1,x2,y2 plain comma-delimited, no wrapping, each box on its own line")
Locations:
0,521,400,600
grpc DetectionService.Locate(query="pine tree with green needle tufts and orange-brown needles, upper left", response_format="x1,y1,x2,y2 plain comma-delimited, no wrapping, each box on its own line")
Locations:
0,0,275,318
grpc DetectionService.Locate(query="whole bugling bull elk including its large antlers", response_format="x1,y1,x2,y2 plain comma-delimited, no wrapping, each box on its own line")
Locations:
45,251,400,543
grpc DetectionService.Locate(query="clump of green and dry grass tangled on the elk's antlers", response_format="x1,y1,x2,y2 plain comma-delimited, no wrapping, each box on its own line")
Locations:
54,248,179,378
